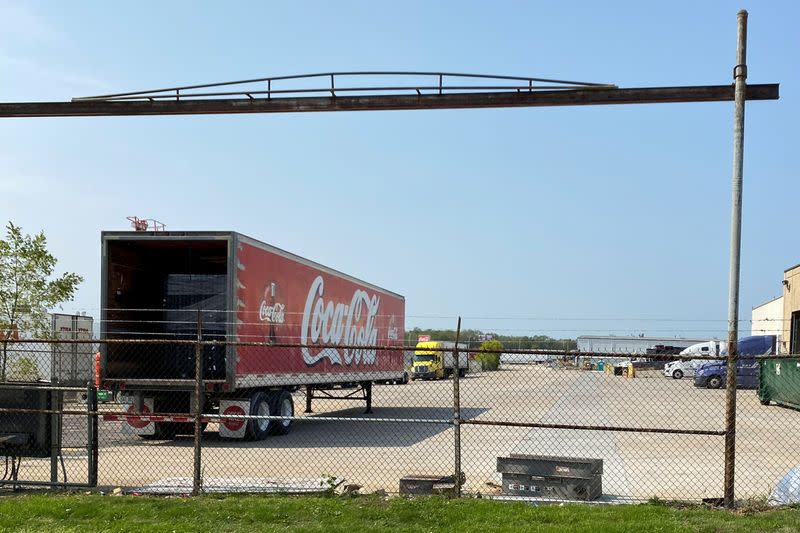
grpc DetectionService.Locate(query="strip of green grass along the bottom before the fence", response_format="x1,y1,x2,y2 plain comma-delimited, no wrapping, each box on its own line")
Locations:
0,494,800,533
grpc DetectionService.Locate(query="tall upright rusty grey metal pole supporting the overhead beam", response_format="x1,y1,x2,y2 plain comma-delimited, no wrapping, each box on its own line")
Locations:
724,10,747,508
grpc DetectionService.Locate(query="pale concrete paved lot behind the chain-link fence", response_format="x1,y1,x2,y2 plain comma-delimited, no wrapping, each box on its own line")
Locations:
12,365,800,500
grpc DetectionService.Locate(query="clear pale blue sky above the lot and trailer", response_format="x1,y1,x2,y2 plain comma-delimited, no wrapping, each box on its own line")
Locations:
0,0,800,336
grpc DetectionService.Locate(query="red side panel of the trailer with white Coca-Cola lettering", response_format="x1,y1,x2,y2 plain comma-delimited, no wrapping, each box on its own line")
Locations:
236,239,405,380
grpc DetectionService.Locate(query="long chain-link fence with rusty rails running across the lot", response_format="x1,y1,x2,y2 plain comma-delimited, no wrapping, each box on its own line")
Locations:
0,330,800,501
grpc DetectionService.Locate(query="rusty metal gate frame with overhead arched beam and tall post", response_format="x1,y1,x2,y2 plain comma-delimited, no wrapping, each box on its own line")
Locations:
0,10,778,507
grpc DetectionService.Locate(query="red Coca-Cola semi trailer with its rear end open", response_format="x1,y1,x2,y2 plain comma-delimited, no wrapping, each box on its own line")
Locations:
101,231,405,440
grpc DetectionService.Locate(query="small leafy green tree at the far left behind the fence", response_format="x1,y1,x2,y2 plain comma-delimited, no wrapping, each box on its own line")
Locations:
0,222,83,381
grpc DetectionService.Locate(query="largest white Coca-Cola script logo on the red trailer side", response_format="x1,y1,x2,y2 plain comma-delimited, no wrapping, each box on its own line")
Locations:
300,276,380,365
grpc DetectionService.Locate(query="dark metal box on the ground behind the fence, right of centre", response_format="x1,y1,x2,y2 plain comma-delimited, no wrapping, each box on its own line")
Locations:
497,454,603,501
